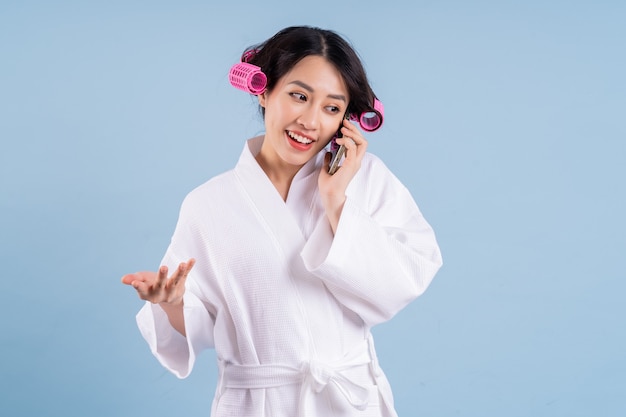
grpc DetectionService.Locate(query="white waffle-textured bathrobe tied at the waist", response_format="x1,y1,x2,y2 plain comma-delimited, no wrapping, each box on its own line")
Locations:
137,137,441,417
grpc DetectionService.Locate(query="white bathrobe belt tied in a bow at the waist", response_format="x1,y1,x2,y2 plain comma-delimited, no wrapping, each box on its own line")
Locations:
219,340,375,415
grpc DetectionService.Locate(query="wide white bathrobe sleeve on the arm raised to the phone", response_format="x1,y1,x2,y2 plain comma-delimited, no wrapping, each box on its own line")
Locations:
301,154,442,326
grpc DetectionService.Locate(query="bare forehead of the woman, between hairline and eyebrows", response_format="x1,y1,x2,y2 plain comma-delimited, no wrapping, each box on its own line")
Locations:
279,55,348,96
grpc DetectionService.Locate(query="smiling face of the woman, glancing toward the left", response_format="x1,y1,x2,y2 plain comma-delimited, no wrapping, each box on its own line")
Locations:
259,56,350,168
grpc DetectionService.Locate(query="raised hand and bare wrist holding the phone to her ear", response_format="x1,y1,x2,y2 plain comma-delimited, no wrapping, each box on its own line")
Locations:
318,120,367,233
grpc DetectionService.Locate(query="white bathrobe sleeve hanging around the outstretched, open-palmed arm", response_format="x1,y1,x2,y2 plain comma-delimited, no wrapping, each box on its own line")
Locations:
137,190,215,378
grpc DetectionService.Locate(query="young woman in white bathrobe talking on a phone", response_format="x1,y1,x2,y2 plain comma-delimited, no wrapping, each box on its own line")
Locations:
122,27,441,417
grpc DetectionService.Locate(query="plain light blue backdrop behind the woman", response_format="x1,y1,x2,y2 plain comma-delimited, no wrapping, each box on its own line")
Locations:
0,0,626,417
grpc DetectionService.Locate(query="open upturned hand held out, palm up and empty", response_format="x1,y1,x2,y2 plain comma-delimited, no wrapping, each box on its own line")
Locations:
122,259,196,306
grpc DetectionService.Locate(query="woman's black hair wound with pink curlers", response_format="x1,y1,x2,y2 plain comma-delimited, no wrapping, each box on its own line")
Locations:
242,26,375,116
